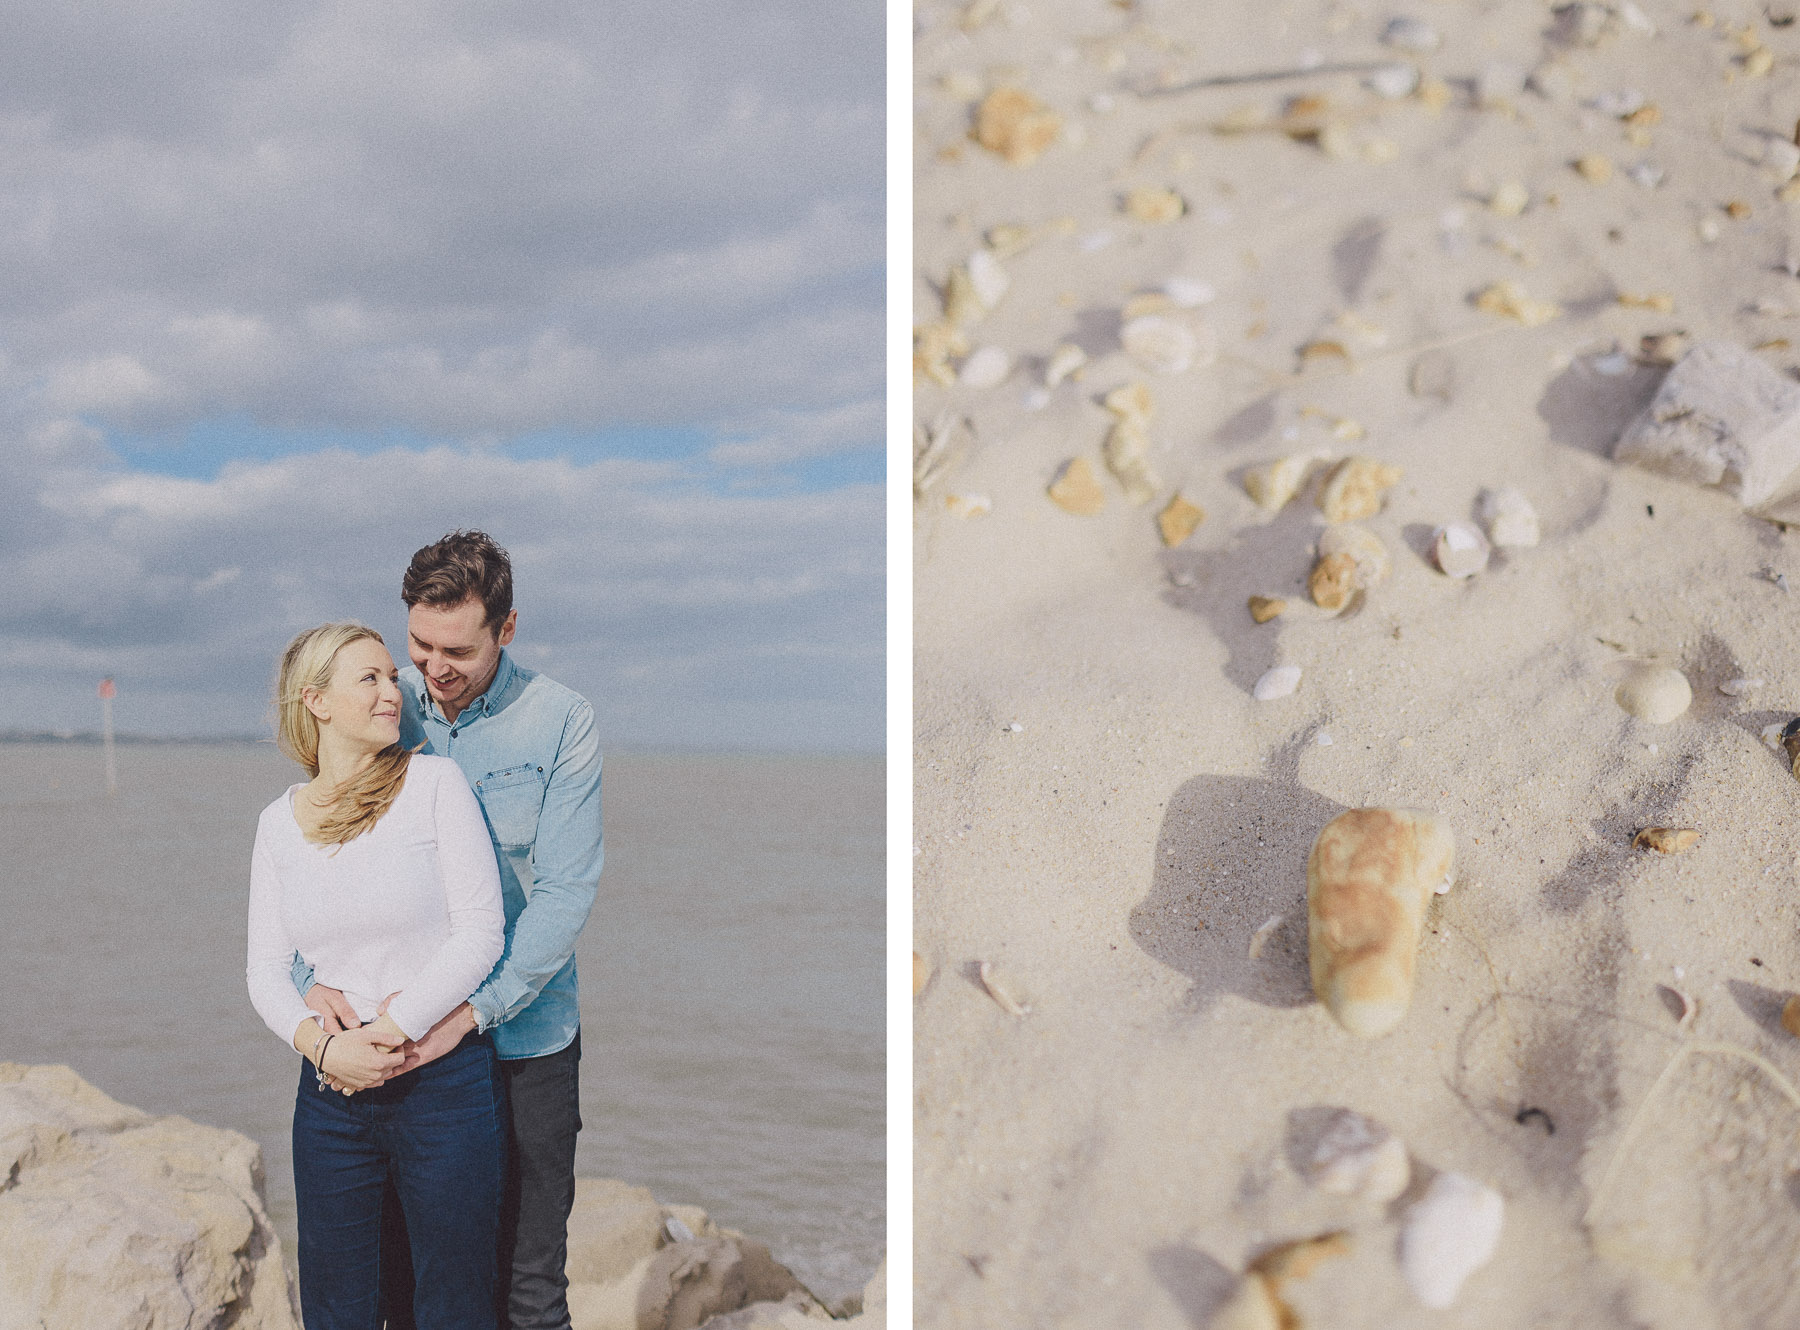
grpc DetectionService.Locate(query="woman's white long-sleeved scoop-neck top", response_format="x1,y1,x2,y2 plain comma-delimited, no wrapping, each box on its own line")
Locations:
245,754,506,1046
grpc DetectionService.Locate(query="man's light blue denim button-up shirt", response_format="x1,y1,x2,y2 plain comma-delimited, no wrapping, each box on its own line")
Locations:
293,650,603,1058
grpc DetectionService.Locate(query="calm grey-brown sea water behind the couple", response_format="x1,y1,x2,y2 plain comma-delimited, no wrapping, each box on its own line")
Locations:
0,743,886,1299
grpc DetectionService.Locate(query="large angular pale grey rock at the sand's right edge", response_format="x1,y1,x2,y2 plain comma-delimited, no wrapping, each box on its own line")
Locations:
1613,342,1800,508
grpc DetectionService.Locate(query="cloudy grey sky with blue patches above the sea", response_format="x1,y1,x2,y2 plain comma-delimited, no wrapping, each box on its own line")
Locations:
0,0,886,750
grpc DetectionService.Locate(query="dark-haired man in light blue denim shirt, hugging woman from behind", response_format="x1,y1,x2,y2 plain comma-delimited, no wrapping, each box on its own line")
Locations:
295,531,601,1330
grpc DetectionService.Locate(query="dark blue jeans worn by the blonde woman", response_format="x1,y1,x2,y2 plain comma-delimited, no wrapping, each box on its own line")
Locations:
293,1035,508,1330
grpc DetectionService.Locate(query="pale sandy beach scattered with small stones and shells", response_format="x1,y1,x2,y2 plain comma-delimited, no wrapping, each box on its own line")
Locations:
913,0,1800,1330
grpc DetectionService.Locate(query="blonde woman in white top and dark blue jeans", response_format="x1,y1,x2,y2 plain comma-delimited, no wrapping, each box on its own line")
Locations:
247,623,506,1330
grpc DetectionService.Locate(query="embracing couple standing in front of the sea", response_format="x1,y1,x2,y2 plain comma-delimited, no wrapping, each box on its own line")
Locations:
247,531,601,1330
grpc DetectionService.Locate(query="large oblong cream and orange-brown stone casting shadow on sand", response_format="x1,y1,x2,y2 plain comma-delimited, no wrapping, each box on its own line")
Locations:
1307,808,1456,1038
